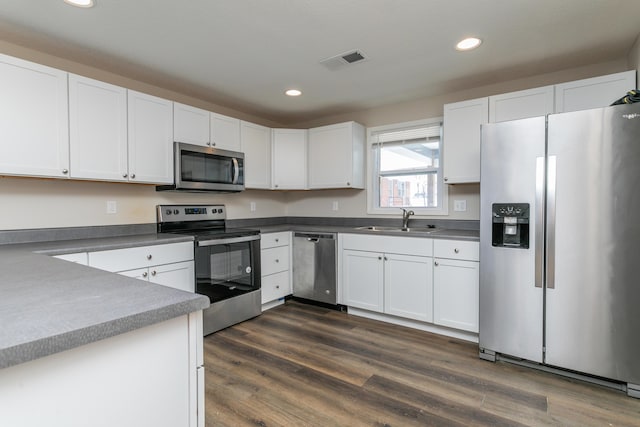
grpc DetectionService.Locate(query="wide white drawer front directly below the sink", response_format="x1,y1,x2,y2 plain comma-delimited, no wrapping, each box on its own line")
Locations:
342,234,433,256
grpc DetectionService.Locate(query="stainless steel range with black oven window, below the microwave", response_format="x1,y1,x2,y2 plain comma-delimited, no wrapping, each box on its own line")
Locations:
157,205,261,335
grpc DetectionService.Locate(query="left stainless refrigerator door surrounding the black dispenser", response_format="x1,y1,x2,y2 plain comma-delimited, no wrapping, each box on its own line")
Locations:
479,117,546,362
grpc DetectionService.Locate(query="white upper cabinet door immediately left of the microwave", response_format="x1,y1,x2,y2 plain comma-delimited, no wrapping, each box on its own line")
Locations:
127,90,173,184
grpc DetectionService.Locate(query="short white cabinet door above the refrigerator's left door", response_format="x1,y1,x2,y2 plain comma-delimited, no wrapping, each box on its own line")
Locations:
489,86,554,123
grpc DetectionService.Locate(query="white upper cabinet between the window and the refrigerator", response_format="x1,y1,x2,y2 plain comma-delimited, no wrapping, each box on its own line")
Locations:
443,98,489,184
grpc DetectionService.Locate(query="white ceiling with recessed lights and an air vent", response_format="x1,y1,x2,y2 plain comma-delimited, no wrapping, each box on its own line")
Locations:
0,0,640,124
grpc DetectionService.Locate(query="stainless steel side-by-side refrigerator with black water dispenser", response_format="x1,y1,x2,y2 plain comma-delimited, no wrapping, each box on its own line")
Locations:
479,104,640,397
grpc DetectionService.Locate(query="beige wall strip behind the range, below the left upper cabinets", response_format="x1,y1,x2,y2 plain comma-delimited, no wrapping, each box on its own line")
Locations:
0,177,286,230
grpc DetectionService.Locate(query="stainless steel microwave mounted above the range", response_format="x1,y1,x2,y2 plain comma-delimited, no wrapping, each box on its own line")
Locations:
156,142,244,193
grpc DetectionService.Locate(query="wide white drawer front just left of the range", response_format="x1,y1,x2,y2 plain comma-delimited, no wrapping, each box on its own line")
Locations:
89,242,193,272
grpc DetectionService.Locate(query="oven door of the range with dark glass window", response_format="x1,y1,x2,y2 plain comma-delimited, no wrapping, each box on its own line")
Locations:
195,234,260,304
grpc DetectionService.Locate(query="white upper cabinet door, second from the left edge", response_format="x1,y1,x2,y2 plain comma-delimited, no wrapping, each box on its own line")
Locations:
69,74,128,181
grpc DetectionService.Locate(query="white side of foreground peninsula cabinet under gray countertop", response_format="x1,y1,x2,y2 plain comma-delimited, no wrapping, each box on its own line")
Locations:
0,311,204,427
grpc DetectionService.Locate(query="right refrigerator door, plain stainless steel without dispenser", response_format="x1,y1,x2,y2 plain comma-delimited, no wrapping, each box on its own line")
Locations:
545,104,640,384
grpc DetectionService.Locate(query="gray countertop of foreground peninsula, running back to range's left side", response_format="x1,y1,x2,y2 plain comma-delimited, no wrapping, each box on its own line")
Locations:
0,234,209,368
